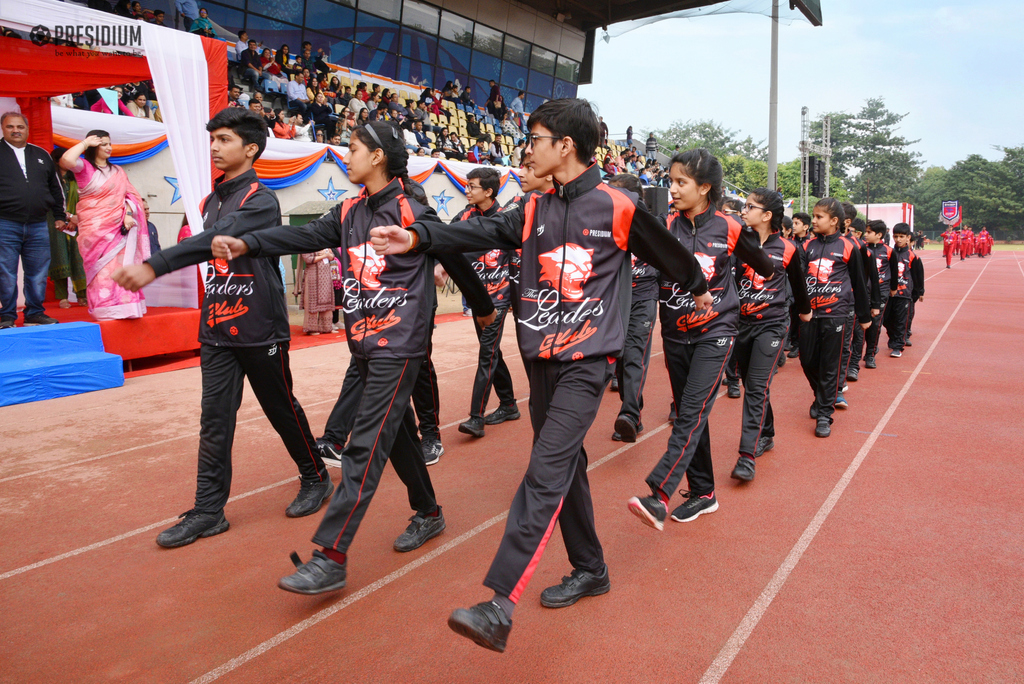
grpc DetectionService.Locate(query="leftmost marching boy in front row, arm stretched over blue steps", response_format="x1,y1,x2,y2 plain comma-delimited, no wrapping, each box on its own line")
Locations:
112,108,334,548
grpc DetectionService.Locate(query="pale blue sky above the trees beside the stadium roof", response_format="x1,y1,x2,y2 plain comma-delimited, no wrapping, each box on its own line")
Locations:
579,0,1024,168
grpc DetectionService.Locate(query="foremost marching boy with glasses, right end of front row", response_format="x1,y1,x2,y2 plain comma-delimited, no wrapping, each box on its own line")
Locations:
366,99,712,651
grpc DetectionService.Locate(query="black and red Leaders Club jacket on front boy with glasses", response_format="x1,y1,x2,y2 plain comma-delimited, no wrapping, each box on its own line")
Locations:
410,165,708,361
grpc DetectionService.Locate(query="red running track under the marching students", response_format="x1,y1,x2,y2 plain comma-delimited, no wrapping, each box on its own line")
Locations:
0,252,1024,682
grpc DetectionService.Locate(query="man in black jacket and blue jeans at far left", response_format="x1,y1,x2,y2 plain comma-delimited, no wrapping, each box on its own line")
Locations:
0,112,67,330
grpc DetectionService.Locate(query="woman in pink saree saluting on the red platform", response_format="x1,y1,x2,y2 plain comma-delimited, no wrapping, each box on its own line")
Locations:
60,130,150,320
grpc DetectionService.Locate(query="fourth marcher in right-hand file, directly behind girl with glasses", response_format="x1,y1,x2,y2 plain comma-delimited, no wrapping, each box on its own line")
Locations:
800,198,871,437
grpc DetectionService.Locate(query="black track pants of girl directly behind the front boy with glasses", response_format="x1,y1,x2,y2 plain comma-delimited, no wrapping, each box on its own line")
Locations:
647,337,733,496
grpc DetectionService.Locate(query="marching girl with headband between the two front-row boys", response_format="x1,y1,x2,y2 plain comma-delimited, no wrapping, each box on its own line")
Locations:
213,122,493,594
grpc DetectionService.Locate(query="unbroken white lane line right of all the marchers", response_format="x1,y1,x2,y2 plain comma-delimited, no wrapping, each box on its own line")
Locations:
700,261,991,684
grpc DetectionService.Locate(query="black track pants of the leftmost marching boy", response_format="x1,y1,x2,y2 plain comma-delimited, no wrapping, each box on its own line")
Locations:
196,342,327,513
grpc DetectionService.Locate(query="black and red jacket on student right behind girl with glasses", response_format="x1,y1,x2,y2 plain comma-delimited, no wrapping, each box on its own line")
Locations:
803,232,871,323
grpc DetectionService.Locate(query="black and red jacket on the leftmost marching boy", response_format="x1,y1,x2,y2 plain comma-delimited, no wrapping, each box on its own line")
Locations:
148,169,291,347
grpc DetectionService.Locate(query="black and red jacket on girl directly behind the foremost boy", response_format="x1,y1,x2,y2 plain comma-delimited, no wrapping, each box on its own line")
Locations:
658,204,770,344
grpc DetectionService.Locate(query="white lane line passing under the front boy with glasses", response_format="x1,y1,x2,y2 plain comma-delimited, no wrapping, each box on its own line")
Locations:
191,421,675,684
